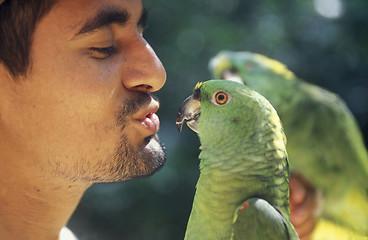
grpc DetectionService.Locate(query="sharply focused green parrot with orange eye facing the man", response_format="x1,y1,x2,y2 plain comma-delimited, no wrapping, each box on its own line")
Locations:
176,80,299,240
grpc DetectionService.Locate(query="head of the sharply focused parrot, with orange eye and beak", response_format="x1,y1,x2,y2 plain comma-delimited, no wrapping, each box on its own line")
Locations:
176,80,284,158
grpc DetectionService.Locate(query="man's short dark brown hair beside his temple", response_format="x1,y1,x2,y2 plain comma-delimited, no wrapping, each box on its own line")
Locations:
0,0,58,77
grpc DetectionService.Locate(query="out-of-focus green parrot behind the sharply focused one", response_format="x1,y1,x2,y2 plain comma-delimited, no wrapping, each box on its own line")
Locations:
209,51,368,234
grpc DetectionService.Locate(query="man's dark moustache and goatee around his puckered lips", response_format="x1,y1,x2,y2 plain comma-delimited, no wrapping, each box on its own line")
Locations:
94,93,166,183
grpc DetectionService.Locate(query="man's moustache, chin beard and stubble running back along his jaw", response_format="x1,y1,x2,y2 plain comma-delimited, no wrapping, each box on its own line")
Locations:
54,93,166,184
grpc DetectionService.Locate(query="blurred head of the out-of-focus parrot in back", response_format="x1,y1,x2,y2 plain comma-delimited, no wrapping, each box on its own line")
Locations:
209,51,295,108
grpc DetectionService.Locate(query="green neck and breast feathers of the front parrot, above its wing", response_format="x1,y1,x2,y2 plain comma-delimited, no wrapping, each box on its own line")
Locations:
188,151,289,239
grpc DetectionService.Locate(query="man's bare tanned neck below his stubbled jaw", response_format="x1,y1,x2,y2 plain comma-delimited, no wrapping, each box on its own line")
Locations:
0,157,89,240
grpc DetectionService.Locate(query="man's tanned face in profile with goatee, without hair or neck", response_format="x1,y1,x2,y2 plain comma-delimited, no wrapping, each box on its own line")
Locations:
1,0,166,182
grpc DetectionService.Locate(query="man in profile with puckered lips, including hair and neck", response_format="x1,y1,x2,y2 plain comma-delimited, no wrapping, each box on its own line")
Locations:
0,0,166,240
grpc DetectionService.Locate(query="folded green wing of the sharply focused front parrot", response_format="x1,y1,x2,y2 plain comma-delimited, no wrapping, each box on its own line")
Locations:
231,198,299,240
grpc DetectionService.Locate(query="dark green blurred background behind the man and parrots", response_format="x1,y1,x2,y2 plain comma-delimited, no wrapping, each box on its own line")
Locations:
68,0,368,240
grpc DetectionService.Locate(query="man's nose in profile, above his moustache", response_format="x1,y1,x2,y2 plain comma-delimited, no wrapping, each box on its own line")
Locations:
122,37,166,92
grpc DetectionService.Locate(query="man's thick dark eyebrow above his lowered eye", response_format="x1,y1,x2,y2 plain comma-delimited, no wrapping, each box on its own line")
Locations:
76,9,130,36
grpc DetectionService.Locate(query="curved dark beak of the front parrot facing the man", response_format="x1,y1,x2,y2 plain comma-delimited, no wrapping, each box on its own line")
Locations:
176,92,201,133
